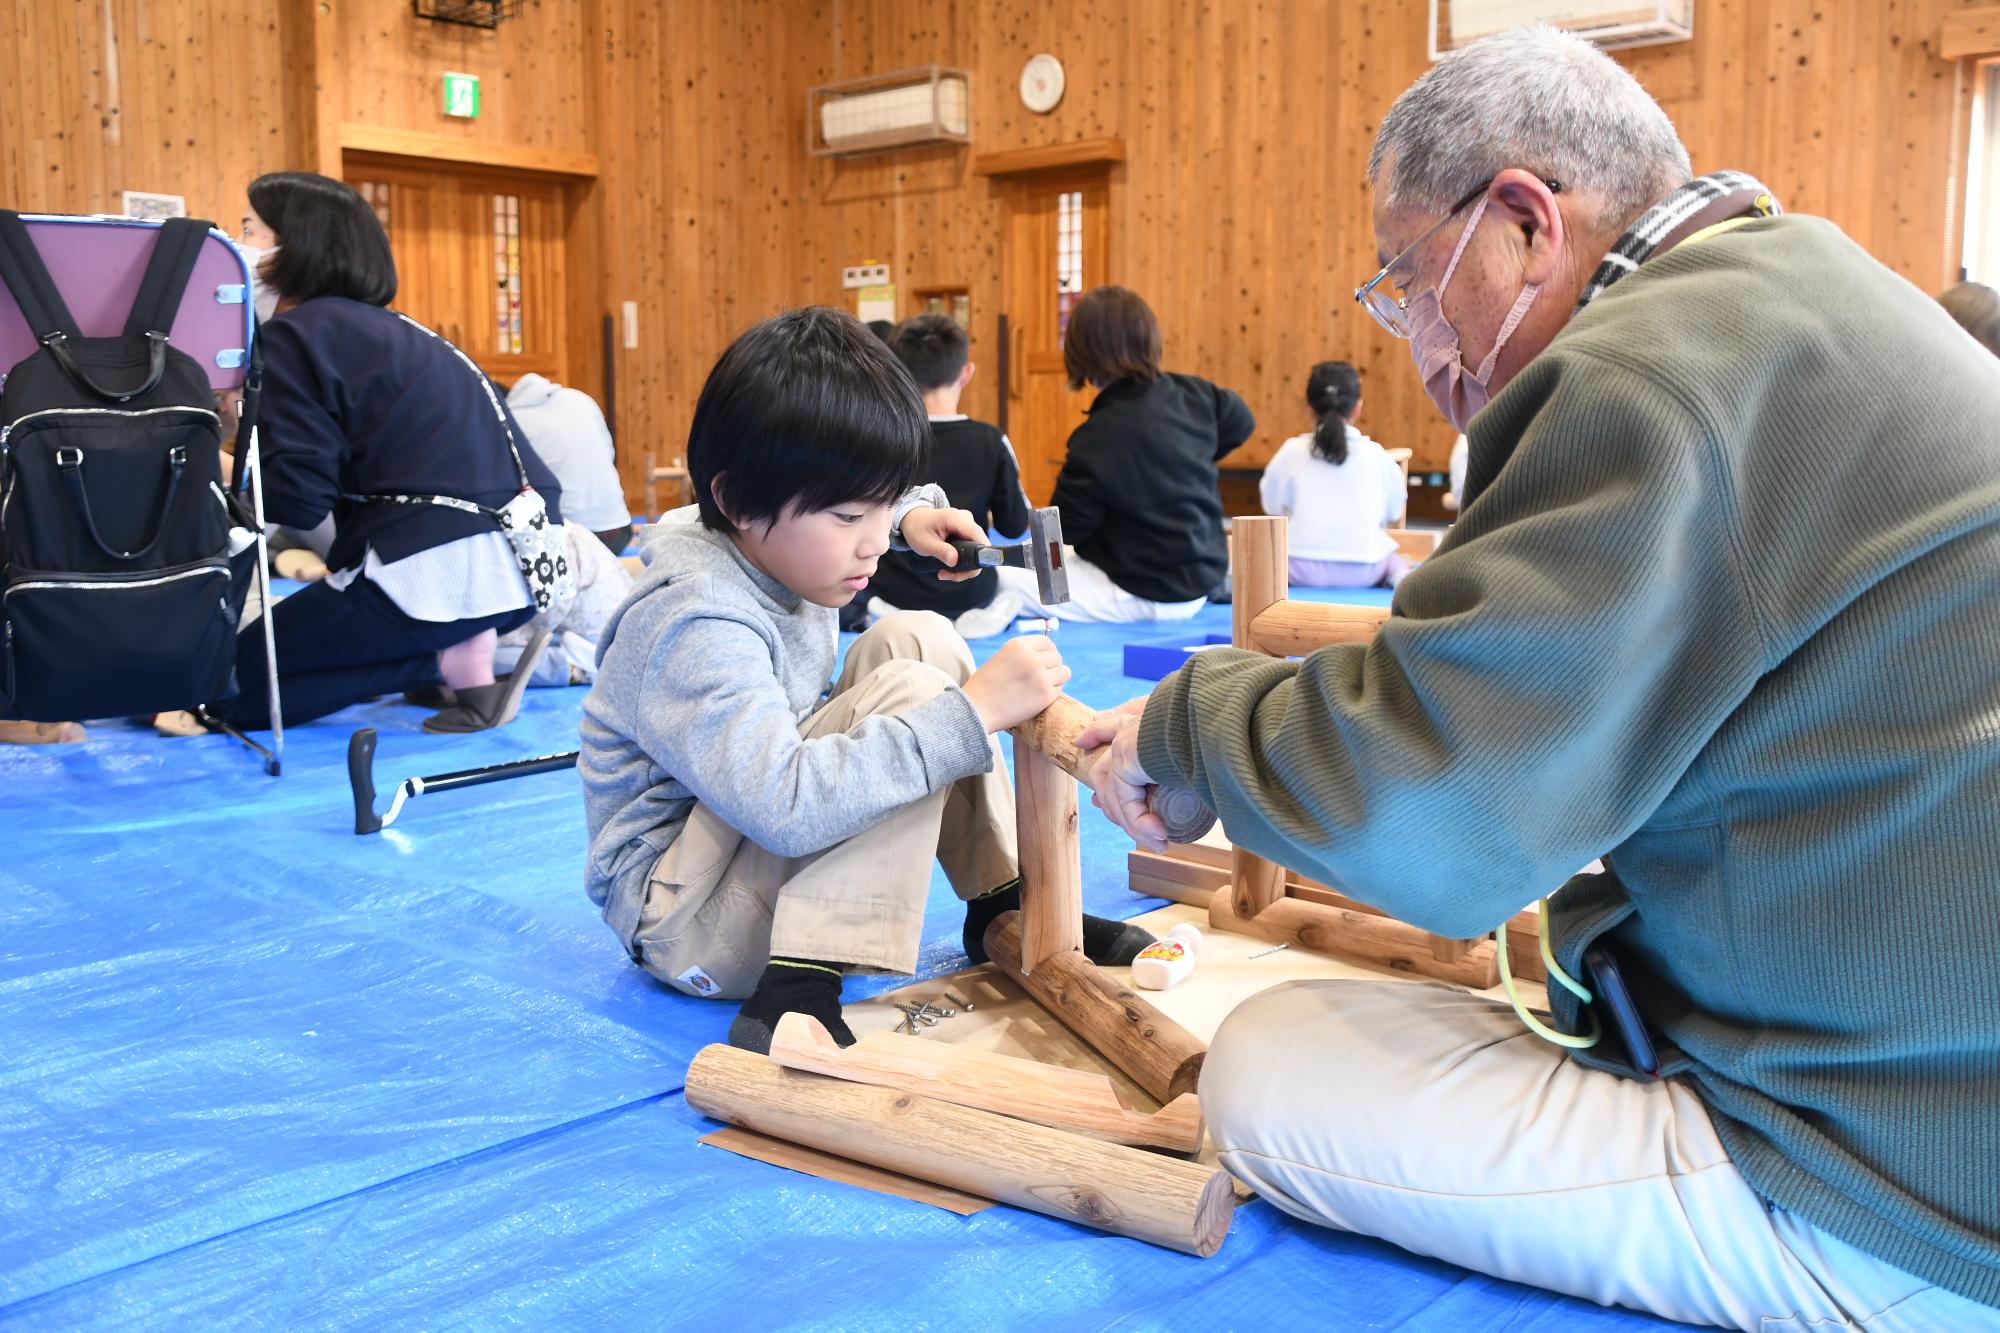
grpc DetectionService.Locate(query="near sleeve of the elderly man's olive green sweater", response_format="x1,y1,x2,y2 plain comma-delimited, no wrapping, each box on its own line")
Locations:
1140,348,1762,937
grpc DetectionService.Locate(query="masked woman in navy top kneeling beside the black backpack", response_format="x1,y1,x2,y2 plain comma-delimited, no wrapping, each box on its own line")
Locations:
212,172,560,731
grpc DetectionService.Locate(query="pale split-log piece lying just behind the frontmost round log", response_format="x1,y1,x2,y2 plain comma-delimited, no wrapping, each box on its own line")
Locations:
770,1013,1202,1157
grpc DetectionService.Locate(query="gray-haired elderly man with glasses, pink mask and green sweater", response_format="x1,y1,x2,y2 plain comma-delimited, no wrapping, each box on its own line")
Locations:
1086,28,2000,1329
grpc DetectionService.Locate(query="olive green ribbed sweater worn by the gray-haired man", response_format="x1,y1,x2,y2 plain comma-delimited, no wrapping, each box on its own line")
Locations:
1140,216,2000,1305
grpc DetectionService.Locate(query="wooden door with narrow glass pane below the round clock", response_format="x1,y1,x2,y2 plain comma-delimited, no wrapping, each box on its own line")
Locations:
1002,168,1110,504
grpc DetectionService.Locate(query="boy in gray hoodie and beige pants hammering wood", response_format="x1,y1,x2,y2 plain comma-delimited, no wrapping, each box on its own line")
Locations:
578,310,1152,1051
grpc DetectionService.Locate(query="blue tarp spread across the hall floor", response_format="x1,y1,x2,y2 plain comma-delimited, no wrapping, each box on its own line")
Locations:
0,592,1658,1329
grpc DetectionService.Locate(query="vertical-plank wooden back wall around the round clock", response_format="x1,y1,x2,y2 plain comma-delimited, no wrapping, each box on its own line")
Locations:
800,0,1974,468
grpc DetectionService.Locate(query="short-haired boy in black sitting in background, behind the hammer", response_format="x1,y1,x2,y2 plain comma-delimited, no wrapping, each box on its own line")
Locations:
868,314,1028,638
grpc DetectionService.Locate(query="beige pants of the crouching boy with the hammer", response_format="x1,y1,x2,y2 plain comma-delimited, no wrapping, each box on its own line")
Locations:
632,610,1020,999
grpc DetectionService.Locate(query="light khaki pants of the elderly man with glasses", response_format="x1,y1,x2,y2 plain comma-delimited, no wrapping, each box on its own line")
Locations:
1202,981,2000,1333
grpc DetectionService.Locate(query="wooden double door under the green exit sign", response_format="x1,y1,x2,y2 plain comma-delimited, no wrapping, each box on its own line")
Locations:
346,154,568,384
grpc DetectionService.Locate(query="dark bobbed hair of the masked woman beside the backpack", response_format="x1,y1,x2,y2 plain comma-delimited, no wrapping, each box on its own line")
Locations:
250,172,396,306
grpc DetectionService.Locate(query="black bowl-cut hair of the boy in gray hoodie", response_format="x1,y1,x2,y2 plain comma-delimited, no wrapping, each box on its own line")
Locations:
688,306,930,532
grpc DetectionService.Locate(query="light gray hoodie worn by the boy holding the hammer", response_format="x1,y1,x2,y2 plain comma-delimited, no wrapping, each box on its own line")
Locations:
576,492,992,945
